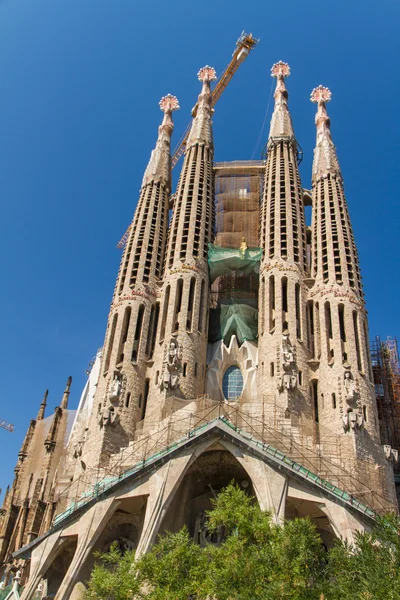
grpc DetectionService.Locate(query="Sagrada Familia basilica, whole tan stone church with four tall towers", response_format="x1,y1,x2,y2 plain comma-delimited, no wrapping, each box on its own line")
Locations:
0,52,397,600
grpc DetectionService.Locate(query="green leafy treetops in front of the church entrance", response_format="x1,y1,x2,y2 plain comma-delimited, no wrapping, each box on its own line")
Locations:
85,484,400,600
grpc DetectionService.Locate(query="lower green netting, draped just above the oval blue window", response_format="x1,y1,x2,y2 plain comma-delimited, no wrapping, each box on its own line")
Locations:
208,303,258,346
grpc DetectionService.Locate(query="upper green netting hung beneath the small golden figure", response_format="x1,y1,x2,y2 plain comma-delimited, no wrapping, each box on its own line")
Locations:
208,244,262,283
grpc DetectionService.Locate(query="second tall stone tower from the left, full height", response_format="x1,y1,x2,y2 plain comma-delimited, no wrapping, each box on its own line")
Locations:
145,65,216,414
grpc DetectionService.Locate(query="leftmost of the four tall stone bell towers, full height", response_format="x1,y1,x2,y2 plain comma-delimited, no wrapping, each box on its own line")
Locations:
77,94,179,473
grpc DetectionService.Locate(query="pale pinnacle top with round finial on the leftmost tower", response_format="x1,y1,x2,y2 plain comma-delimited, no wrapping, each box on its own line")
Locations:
142,94,180,188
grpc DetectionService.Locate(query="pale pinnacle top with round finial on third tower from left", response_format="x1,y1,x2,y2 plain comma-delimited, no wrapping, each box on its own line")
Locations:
269,61,294,139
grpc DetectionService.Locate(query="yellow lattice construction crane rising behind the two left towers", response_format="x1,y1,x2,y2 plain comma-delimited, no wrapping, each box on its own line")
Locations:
117,31,259,249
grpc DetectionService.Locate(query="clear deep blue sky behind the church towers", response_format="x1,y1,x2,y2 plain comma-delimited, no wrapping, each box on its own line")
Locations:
0,0,400,488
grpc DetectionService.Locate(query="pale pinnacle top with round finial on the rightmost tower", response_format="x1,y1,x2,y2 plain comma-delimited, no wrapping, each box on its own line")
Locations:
311,85,341,182
